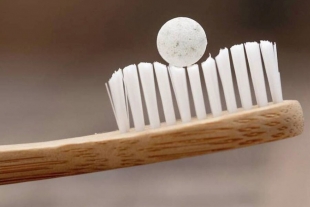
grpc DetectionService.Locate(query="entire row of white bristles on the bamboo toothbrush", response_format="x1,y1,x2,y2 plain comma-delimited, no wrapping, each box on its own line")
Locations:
106,41,283,133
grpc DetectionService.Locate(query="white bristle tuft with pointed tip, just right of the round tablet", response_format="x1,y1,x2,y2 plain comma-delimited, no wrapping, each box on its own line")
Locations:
201,56,222,117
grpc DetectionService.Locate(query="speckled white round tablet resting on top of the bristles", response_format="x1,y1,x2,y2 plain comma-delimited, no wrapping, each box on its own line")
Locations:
157,17,207,67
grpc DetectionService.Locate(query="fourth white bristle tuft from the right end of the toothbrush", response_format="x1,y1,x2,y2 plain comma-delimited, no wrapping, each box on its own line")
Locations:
215,48,237,113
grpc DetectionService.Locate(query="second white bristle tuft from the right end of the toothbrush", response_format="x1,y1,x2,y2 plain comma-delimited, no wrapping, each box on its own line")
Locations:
245,42,268,106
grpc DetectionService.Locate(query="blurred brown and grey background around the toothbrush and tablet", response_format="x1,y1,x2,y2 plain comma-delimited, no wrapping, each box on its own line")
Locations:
0,0,310,207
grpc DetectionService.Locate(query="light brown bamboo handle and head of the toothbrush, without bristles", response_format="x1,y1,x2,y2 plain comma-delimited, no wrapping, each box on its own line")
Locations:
0,101,303,184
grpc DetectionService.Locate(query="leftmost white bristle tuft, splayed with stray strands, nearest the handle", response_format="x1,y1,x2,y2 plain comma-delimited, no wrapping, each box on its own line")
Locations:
106,69,129,133
